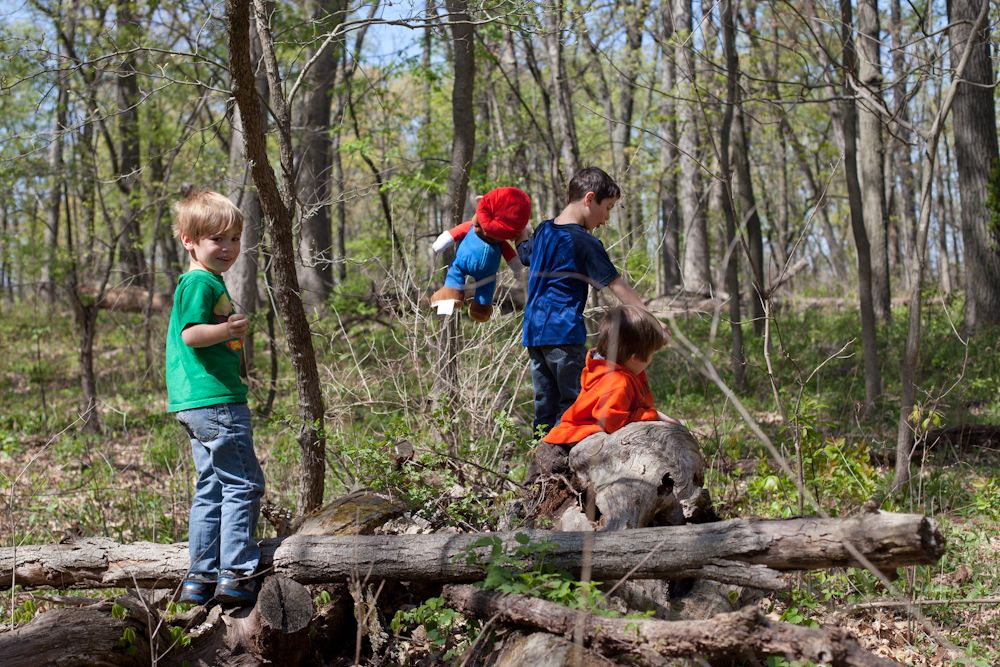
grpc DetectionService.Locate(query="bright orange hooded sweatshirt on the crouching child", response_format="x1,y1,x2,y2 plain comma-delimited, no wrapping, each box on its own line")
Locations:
542,350,660,445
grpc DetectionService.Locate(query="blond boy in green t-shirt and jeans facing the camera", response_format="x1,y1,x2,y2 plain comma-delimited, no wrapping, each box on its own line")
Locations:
166,190,264,604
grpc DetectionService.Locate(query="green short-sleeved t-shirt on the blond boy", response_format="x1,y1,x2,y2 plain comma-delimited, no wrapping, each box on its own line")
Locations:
167,270,247,412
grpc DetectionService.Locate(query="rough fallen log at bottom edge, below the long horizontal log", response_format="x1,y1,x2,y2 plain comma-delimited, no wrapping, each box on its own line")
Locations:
443,586,898,667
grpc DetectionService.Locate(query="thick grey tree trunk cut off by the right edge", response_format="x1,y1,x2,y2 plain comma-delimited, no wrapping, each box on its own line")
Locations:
948,0,1000,332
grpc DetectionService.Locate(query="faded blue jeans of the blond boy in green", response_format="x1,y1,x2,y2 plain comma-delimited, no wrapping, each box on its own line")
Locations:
177,403,264,580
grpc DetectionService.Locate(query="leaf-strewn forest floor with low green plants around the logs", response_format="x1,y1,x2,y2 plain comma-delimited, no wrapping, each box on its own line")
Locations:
0,304,1000,666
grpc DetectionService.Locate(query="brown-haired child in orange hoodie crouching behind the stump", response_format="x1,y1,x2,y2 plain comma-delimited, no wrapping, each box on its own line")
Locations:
529,306,680,479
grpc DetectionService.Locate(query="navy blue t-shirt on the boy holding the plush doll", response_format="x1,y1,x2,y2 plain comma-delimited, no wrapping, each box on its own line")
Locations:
517,220,618,347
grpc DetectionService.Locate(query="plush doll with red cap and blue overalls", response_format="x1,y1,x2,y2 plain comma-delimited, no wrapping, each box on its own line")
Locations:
431,188,531,322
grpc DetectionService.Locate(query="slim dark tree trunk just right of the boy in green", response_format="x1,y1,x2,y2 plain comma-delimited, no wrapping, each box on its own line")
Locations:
226,0,326,512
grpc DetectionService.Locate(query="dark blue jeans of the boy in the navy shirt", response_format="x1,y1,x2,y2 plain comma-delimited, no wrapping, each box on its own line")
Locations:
528,345,587,434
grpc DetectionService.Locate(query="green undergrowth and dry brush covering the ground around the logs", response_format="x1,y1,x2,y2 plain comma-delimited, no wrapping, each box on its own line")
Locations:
0,298,1000,660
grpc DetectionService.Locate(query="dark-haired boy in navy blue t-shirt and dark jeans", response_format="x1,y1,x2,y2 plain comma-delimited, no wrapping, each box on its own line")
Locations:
517,167,664,435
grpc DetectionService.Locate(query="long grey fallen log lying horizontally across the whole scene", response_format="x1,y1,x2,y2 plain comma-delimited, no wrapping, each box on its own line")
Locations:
0,512,944,588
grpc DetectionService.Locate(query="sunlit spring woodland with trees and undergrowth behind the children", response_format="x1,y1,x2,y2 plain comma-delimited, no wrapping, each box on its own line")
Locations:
0,0,1000,664
